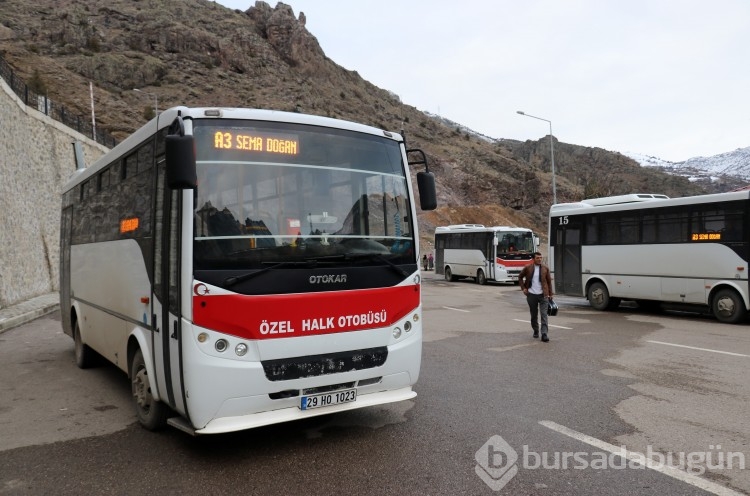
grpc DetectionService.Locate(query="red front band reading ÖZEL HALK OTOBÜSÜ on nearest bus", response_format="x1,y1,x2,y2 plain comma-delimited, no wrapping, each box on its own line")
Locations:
193,285,420,339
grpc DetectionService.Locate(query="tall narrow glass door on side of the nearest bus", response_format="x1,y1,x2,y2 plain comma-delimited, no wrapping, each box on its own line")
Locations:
152,165,187,415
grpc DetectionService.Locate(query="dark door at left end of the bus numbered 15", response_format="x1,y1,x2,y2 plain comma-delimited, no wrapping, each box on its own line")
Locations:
552,215,584,296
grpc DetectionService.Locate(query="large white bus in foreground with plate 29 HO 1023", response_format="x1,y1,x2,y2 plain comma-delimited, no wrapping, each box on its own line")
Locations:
60,107,435,434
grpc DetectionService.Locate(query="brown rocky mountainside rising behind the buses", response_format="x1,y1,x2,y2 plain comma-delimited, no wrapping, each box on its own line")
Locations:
0,0,716,247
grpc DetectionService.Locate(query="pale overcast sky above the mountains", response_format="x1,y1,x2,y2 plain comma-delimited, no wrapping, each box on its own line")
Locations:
218,0,750,161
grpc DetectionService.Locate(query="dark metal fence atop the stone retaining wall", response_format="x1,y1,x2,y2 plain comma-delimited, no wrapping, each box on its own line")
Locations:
0,56,117,148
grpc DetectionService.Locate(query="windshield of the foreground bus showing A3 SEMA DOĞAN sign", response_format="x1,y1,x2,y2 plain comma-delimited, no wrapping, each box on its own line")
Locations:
194,120,415,270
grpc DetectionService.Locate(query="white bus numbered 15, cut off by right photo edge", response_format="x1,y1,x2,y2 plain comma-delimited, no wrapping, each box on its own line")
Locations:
549,191,750,323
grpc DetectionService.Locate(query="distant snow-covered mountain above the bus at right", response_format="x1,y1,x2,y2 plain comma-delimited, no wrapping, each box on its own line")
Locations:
626,147,750,193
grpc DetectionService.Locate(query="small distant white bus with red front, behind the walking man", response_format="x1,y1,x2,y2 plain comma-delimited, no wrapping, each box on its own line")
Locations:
435,224,539,284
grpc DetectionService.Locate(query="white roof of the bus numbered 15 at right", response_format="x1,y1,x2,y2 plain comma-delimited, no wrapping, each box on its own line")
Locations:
550,191,750,216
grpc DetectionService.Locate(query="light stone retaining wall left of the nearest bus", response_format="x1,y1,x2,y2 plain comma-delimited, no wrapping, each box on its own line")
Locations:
0,79,108,309
